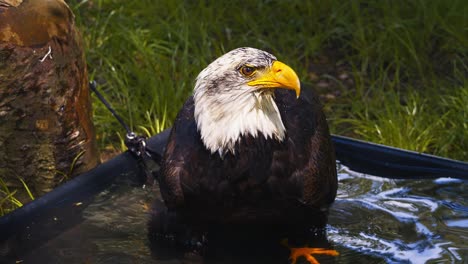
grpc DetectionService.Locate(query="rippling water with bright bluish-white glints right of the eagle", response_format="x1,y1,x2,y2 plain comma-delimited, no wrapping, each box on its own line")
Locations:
328,167,468,263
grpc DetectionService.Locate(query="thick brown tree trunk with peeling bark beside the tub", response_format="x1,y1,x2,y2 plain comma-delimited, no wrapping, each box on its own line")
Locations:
0,0,99,199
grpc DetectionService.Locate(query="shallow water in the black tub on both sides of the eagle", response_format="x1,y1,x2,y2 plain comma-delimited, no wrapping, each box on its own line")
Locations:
12,164,468,264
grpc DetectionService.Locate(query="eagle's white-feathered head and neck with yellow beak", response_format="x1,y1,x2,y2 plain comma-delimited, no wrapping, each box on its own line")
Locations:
193,48,300,156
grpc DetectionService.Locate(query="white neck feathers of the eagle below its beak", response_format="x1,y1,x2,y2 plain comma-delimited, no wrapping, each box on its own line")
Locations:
194,89,286,157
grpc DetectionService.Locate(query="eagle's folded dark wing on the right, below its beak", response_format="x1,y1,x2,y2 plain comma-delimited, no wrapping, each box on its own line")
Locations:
274,85,338,207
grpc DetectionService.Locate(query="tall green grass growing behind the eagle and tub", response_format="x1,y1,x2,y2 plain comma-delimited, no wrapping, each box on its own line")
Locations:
70,0,468,160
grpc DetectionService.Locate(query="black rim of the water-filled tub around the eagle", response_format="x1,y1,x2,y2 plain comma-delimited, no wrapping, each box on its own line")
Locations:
0,130,468,263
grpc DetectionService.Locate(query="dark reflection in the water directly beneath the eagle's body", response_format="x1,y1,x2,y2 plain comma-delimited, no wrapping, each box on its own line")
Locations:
148,199,334,263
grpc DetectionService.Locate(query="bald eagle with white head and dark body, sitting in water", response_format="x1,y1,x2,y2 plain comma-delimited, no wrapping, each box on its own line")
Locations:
155,47,337,262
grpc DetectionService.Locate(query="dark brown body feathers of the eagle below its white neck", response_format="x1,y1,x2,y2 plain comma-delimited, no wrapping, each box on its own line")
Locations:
160,89,337,229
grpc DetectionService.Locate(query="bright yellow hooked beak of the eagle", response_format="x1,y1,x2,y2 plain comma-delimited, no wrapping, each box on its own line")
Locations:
247,61,301,98
